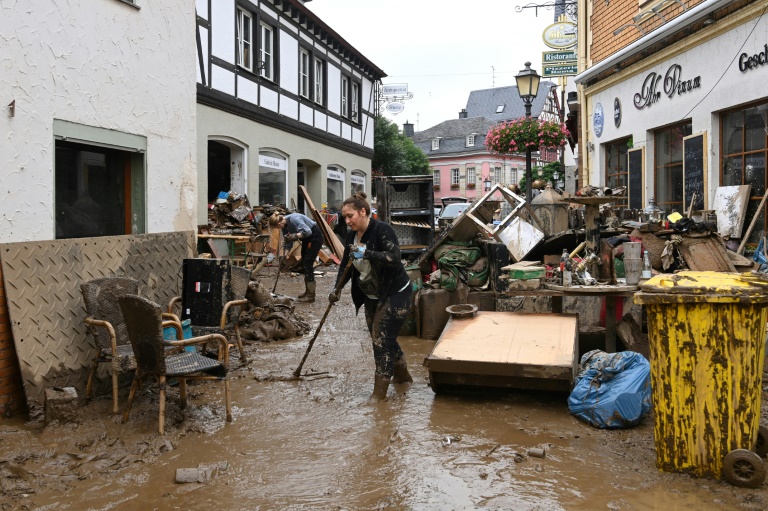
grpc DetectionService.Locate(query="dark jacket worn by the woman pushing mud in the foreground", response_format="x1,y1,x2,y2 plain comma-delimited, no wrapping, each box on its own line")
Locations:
336,218,410,310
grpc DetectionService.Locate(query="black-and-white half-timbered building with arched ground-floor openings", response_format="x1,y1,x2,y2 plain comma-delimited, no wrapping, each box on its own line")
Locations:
196,0,385,218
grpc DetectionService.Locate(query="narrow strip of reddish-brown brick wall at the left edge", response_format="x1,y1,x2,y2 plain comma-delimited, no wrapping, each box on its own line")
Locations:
0,266,27,417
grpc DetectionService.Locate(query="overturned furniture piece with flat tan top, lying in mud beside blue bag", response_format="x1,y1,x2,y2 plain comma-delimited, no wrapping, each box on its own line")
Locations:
424,311,579,393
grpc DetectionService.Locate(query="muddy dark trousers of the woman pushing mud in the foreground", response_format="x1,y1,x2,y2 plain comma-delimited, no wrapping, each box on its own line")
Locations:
365,283,411,378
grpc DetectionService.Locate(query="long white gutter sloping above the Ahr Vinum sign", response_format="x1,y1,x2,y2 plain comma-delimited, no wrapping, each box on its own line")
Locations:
573,0,733,85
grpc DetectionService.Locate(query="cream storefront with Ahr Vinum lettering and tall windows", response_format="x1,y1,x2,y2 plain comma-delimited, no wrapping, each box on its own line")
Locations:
576,2,768,240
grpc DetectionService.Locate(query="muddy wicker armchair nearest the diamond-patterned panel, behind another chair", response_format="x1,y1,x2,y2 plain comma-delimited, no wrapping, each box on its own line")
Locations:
80,277,183,413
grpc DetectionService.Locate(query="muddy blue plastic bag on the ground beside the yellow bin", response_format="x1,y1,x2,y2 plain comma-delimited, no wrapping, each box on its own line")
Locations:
568,350,651,429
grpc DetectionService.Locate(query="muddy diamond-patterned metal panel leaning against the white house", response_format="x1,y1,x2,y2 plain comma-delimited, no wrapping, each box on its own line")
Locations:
0,231,195,420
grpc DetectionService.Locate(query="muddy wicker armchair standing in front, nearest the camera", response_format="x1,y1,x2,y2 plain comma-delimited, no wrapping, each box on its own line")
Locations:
118,295,232,435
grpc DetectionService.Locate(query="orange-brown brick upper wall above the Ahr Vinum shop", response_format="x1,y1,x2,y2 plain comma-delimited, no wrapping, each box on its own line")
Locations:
589,0,703,65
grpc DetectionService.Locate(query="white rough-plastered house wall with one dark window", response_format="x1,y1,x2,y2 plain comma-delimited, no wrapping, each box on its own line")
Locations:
0,0,197,242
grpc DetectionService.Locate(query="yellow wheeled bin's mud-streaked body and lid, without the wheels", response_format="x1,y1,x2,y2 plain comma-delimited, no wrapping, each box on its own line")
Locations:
635,271,768,479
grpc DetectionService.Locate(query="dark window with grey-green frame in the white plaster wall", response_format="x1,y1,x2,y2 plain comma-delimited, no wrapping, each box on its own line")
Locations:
53,120,146,239
